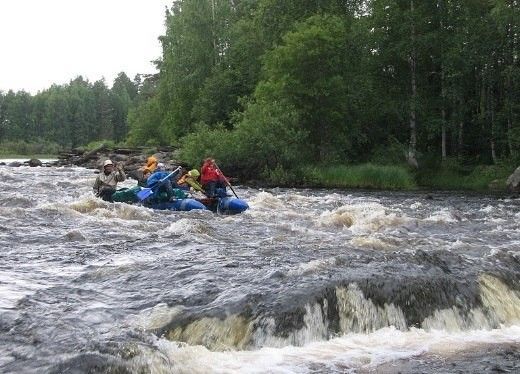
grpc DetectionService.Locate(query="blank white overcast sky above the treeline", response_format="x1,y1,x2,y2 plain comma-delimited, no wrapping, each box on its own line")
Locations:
0,0,172,94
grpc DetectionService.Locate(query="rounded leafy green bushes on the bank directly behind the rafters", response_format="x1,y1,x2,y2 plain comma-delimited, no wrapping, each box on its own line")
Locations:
180,96,306,177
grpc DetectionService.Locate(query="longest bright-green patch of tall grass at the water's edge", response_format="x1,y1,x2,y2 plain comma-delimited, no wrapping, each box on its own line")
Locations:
302,164,415,190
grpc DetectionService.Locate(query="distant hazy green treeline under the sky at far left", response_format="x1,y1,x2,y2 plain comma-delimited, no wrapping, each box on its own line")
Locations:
0,73,139,148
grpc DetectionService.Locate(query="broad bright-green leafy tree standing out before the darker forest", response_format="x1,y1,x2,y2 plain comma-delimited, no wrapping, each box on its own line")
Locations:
255,15,359,161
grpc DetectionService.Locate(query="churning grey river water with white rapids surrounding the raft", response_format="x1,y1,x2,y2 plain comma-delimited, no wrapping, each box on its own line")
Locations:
0,166,520,373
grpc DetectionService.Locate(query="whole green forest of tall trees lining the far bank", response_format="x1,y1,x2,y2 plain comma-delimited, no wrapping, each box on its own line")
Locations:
0,0,520,184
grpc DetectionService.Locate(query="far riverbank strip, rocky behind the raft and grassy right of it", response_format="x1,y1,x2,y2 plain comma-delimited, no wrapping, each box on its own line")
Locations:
0,143,520,193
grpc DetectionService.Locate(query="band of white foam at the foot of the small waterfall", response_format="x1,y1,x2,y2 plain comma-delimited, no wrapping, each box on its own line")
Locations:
130,326,520,373
